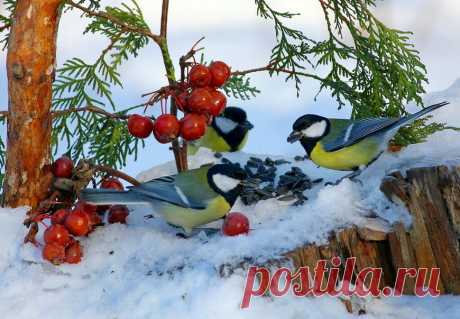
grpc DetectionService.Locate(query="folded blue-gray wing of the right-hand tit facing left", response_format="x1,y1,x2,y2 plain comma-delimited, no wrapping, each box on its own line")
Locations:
321,118,399,152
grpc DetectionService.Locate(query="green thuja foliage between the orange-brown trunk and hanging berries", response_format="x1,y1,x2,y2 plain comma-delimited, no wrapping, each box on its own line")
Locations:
53,1,149,168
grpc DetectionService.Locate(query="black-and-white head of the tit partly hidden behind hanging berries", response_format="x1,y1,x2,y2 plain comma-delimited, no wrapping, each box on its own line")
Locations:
212,106,254,151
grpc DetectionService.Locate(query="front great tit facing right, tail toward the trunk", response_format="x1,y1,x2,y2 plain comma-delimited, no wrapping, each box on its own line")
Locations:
80,164,246,234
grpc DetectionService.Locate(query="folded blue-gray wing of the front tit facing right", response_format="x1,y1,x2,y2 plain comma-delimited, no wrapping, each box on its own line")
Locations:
130,169,215,209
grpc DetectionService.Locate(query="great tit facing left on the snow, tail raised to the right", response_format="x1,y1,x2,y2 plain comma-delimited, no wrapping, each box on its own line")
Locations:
287,102,449,175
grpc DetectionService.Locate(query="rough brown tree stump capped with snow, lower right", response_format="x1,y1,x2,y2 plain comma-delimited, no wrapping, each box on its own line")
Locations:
286,166,460,300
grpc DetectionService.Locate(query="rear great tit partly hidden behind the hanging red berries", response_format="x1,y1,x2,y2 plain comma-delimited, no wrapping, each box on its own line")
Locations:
188,106,254,155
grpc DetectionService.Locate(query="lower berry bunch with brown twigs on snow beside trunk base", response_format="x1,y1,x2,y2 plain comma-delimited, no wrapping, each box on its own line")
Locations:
24,156,134,265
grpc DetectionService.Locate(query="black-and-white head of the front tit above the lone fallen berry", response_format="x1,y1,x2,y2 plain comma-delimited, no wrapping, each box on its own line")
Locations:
208,164,247,205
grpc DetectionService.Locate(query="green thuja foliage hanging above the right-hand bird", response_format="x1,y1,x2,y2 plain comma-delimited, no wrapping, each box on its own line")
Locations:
255,0,446,145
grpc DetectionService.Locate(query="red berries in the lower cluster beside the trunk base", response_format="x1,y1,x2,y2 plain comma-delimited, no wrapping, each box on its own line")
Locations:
40,156,129,265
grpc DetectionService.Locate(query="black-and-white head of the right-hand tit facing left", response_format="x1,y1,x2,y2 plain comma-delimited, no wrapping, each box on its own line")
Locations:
287,114,331,154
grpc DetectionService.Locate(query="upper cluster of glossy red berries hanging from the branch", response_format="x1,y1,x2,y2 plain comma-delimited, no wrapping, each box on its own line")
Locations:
128,61,231,144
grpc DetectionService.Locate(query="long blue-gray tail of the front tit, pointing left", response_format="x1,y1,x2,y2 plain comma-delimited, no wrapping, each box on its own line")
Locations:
80,188,148,205
